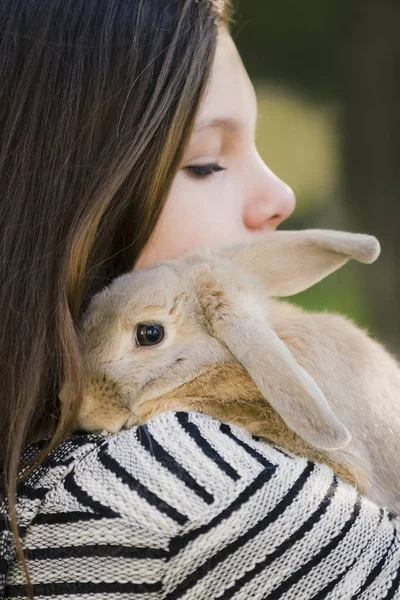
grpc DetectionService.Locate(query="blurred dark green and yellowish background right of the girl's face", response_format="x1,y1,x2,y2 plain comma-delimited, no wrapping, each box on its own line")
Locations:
232,0,400,356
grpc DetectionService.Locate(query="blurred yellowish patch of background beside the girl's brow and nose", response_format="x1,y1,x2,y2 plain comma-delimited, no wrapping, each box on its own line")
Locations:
255,81,340,212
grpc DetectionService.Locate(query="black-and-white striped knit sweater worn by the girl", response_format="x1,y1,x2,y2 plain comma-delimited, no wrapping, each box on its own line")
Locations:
0,412,400,600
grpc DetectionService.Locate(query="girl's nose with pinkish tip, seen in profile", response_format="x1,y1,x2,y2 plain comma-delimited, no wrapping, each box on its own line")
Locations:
244,157,296,231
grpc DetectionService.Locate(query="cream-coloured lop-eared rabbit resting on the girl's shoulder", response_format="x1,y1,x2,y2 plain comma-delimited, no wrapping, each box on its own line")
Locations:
60,230,400,513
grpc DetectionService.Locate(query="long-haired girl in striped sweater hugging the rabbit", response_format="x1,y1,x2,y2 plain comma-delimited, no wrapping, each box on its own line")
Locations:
0,0,400,600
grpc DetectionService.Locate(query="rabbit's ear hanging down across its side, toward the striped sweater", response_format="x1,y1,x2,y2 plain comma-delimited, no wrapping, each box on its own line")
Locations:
213,317,351,450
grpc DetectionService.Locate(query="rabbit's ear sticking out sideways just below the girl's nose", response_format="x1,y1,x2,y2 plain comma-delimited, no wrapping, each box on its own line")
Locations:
215,229,380,296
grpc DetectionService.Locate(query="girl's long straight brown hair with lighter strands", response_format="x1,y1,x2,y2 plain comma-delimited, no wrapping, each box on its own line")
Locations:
0,0,229,597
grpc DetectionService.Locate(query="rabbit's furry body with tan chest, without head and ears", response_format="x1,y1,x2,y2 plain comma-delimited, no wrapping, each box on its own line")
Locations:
133,301,400,513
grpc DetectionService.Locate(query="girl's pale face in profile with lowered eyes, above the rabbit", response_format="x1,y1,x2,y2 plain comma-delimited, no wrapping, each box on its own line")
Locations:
135,29,295,269
